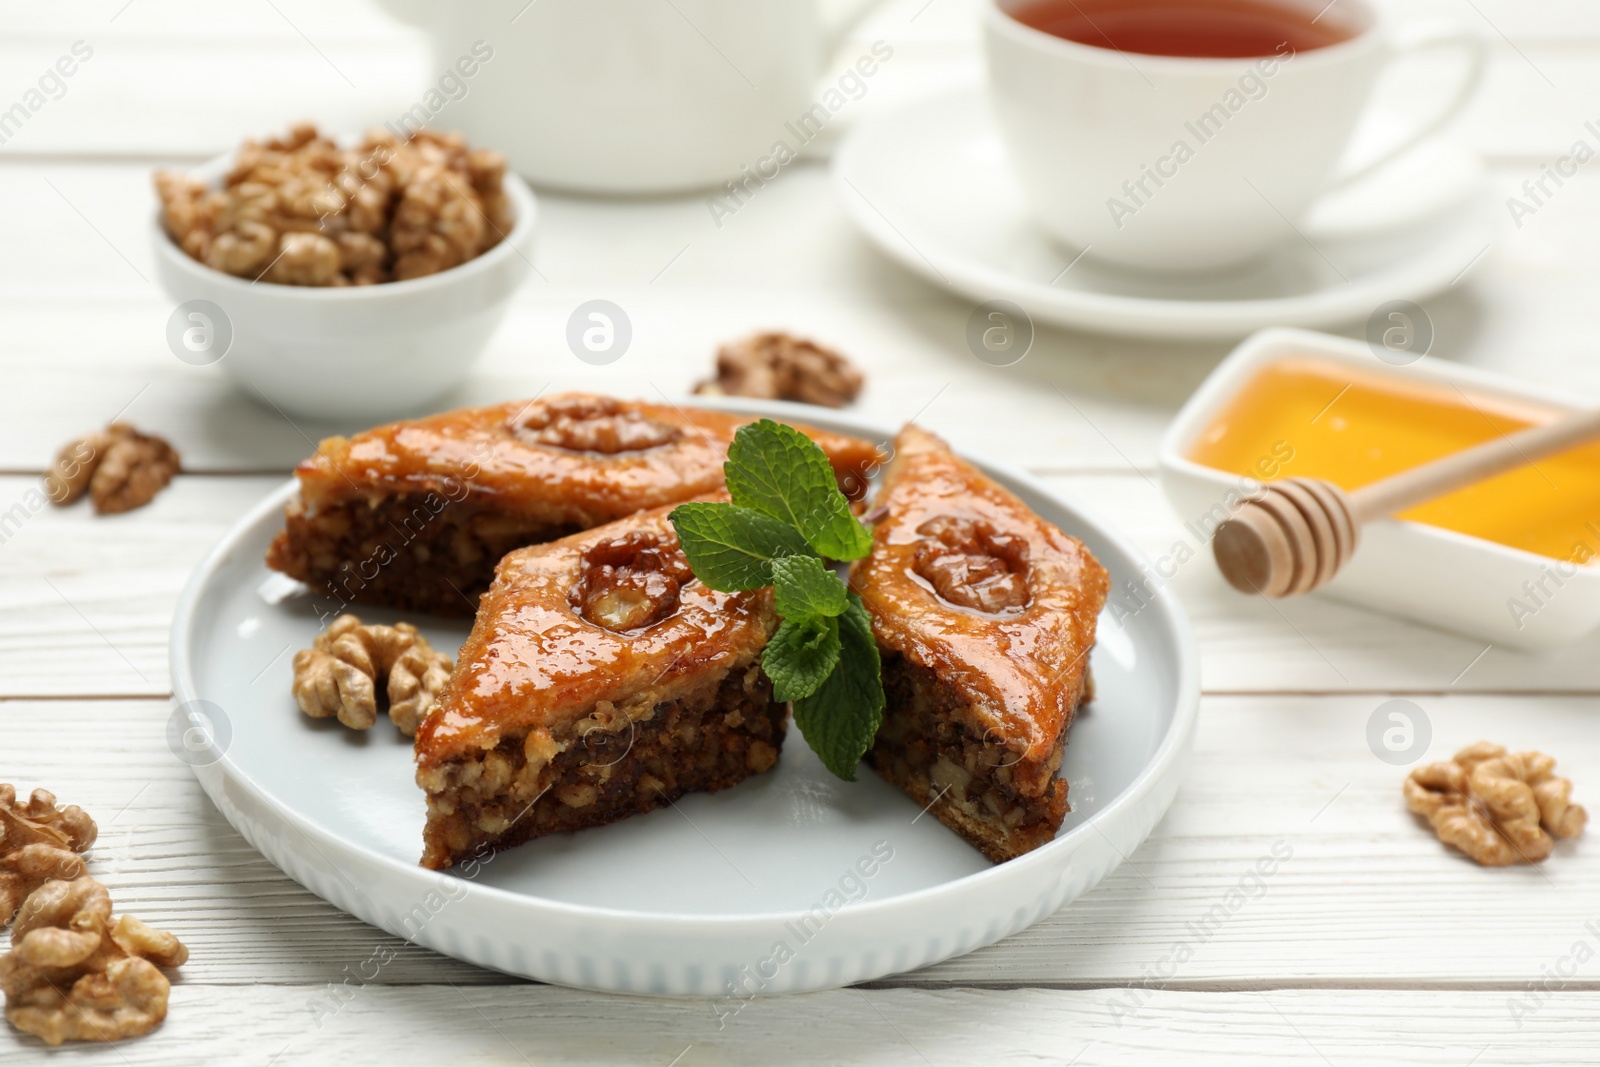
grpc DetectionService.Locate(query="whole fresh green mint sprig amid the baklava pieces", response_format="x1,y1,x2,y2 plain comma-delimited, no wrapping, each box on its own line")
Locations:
670,419,883,782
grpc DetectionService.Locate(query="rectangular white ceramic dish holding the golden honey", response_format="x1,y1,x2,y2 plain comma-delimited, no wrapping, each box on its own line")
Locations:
1160,330,1600,649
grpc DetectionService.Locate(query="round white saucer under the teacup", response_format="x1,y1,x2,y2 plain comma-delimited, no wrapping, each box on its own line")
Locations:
834,83,1498,338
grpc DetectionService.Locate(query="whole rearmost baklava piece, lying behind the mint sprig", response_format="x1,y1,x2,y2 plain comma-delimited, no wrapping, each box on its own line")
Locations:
267,394,878,614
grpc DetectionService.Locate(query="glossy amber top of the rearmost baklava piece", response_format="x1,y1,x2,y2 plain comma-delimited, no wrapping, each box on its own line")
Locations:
296,394,878,528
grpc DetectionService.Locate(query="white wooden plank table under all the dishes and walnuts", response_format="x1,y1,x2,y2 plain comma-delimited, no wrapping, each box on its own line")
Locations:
0,0,1600,1067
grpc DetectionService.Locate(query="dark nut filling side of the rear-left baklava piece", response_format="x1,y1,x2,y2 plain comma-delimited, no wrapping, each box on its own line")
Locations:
267,493,578,616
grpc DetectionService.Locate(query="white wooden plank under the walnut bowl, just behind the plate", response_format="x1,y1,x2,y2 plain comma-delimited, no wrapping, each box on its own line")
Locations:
0,163,1600,472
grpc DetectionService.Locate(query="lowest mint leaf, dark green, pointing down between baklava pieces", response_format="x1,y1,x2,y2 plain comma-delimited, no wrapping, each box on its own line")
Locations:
795,593,883,782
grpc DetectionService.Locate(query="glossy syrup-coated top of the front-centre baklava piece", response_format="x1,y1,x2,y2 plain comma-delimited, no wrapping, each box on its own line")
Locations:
416,494,778,768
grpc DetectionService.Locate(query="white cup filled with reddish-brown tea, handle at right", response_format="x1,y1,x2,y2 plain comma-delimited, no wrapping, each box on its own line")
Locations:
984,0,1488,270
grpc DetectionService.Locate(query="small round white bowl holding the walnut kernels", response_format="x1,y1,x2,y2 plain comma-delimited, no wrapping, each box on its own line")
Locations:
152,154,538,422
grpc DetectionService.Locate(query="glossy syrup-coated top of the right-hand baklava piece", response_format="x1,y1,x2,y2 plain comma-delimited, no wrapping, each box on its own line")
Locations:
850,426,1109,771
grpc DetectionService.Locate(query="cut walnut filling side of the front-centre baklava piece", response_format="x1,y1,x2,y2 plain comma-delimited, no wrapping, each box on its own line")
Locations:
418,664,786,870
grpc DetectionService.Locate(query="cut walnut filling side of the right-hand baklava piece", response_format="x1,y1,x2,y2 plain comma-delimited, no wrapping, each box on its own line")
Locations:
867,654,1069,862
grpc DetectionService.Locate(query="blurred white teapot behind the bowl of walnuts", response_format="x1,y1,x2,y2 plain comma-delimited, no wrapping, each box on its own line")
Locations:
382,0,893,194
